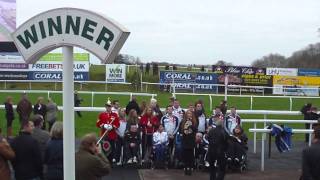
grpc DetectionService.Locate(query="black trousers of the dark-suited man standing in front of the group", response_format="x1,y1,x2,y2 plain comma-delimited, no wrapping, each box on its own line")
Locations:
210,154,226,180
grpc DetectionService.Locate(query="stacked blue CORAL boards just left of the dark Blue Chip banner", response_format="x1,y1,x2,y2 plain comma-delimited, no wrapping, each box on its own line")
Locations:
159,71,217,91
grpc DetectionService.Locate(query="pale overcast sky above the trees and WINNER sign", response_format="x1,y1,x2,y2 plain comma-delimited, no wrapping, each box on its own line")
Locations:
17,0,320,65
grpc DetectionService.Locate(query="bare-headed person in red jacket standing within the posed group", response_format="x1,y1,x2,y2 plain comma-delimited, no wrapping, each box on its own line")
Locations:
139,107,160,160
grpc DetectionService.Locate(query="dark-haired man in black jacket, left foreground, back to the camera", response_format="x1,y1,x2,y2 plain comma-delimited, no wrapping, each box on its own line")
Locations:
11,121,43,180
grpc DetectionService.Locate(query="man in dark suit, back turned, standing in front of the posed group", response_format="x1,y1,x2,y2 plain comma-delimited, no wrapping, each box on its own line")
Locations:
208,117,228,180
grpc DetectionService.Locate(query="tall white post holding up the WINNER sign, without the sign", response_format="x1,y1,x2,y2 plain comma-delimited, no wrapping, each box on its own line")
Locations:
62,46,75,180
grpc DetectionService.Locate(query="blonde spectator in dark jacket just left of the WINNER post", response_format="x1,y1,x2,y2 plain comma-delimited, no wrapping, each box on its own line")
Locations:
44,121,63,180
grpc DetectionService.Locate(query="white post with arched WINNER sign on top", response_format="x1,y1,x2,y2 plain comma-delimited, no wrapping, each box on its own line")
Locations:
12,8,129,180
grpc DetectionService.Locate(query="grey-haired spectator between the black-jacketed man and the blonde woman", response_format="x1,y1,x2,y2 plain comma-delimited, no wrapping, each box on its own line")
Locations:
31,114,50,159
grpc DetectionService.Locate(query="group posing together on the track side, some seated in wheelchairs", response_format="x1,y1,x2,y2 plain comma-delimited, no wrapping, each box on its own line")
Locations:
96,97,247,179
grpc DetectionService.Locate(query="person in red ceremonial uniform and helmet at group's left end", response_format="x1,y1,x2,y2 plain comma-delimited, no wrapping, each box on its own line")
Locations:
96,100,120,162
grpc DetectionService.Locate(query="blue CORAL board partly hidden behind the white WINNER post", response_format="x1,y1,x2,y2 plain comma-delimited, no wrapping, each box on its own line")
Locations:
29,71,89,81
